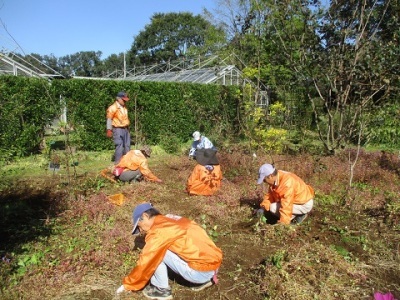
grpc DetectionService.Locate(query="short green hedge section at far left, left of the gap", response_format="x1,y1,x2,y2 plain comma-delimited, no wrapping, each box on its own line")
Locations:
0,76,60,160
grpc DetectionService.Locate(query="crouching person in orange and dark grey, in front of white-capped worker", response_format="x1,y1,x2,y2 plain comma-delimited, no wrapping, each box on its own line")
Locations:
186,149,222,196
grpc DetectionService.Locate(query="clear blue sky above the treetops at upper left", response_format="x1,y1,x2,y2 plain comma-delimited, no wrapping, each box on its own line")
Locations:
0,0,216,59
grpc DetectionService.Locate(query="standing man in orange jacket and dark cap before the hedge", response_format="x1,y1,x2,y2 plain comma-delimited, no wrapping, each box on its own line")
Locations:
106,92,131,164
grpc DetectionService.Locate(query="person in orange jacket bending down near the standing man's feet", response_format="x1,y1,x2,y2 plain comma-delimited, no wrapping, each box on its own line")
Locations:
114,145,162,182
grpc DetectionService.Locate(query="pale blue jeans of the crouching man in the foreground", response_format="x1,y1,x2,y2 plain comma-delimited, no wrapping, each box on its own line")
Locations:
150,250,215,288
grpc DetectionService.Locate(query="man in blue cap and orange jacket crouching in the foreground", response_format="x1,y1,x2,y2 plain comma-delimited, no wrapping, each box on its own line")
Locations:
117,203,222,299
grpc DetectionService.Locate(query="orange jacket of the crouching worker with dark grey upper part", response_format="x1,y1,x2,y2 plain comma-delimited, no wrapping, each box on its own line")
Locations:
186,164,222,196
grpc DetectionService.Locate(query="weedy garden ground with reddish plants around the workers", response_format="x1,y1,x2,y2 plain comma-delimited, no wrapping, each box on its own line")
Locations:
0,147,400,300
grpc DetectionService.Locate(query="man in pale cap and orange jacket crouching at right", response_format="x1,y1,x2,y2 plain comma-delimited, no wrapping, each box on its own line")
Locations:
257,164,315,224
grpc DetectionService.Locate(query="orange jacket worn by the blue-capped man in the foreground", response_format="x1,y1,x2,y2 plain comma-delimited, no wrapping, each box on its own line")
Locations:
123,215,222,291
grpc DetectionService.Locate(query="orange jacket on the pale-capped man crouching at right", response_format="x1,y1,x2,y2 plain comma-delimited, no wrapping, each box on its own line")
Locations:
260,170,315,224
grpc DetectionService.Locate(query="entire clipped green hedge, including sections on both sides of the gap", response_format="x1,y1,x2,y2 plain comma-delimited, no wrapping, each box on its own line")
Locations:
0,76,239,156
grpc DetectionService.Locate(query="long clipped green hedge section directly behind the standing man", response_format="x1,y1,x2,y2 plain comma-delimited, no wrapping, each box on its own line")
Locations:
52,79,238,150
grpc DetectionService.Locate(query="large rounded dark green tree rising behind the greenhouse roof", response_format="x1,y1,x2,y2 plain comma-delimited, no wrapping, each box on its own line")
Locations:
129,12,220,65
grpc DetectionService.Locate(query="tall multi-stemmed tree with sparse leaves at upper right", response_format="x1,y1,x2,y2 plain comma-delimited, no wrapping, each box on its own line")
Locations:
241,0,399,153
